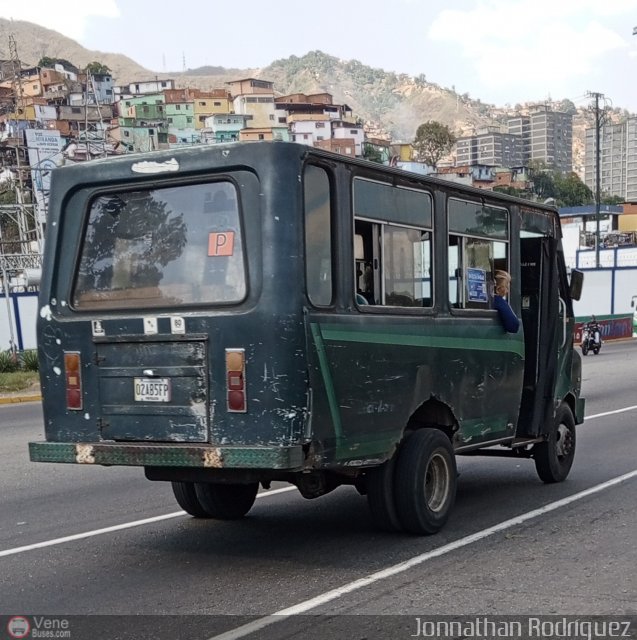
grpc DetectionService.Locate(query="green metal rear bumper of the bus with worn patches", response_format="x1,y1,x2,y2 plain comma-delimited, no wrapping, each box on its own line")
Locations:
29,442,303,471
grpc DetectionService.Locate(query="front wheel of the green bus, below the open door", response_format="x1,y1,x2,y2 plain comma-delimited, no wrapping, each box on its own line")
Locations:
533,403,575,483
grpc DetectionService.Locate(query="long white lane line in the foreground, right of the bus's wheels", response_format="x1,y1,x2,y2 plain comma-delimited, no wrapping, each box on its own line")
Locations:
209,469,637,640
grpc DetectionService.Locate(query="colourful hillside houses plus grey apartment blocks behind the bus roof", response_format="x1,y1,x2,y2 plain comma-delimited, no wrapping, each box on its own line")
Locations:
0,61,608,205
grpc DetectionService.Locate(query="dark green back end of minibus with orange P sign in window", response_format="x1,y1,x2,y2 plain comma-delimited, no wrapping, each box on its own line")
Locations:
30,143,308,477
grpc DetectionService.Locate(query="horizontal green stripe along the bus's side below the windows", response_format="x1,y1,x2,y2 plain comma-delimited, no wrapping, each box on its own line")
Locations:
312,325,524,357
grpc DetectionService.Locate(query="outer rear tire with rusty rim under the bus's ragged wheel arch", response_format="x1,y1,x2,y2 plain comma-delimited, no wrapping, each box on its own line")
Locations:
394,428,458,535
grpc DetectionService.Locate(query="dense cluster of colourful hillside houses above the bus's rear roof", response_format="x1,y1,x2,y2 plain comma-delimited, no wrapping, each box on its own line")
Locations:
0,65,365,156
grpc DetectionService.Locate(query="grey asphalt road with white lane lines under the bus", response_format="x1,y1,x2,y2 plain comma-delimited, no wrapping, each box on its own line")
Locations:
0,341,637,639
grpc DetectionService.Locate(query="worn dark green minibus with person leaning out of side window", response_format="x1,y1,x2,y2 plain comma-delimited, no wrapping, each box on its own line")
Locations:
29,142,584,534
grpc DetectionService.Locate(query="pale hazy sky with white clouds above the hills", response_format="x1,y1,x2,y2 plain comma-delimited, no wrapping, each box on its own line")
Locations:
0,0,637,112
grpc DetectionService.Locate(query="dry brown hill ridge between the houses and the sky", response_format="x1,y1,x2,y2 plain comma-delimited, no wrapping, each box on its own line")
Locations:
0,18,619,172
